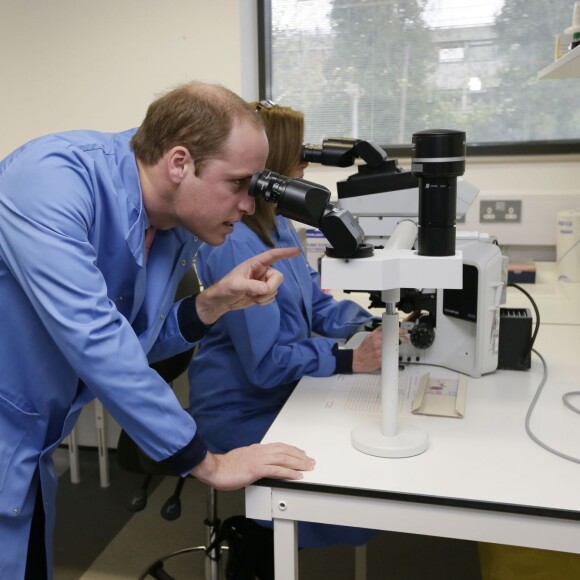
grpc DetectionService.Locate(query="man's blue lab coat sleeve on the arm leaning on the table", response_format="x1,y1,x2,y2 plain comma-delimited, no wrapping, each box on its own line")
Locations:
0,148,205,469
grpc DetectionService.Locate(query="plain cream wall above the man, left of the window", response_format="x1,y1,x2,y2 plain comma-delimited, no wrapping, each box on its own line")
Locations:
0,0,258,158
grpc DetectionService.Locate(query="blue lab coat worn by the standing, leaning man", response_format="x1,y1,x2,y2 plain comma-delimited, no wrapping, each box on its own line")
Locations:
0,130,205,578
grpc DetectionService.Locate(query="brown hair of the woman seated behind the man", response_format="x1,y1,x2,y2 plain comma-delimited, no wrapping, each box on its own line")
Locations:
242,102,304,248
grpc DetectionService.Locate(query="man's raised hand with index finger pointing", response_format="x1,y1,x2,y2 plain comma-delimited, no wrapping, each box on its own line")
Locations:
195,248,300,324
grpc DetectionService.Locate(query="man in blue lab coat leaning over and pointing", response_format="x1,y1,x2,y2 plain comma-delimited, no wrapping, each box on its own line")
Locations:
0,83,313,580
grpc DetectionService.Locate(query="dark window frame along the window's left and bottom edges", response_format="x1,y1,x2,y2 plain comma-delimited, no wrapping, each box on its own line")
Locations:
257,0,580,157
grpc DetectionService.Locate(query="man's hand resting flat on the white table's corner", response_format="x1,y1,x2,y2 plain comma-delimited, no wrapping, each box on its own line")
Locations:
191,443,315,491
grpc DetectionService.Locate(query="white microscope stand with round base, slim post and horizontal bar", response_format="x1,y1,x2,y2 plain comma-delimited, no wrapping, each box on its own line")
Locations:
322,222,463,457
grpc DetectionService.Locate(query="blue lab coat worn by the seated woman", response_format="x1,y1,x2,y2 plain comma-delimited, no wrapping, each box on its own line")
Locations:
189,216,376,547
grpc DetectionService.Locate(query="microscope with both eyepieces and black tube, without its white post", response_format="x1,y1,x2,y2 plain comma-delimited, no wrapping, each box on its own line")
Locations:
250,129,507,377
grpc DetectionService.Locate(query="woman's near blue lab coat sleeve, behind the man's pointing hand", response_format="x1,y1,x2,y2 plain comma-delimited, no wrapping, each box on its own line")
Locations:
197,240,368,388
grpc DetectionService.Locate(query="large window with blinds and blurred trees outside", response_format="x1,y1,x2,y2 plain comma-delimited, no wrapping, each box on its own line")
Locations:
261,0,580,153
